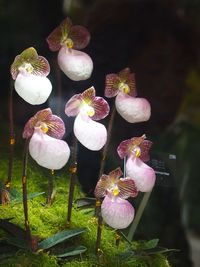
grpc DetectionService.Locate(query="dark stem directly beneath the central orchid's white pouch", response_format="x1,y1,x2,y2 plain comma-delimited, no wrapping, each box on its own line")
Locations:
67,136,78,224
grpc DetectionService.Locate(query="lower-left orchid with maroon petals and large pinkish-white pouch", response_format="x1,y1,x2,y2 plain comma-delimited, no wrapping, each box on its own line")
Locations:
23,108,70,170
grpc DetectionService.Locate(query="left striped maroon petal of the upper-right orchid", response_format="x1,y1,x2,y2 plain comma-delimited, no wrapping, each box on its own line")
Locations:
104,73,120,98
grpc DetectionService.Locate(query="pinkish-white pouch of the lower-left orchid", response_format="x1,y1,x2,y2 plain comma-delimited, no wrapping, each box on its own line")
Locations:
29,128,70,170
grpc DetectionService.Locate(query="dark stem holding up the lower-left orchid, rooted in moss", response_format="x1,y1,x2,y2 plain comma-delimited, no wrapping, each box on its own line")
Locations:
22,139,33,250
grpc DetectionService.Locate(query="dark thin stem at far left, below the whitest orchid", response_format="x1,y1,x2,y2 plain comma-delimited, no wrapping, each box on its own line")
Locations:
1,81,15,204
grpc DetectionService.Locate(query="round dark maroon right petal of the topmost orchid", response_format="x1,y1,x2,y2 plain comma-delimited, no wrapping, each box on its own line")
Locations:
69,25,90,50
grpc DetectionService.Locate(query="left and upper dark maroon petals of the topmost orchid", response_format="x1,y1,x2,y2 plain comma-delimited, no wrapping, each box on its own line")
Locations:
46,18,72,51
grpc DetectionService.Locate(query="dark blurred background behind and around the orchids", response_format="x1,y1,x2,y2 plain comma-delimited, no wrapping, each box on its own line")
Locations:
0,0,200,267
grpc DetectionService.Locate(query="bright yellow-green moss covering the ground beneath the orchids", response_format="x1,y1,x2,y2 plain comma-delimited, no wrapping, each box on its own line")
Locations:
0,127,172,267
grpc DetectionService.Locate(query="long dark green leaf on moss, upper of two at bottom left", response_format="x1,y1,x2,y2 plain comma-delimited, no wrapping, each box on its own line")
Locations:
38,228,86,249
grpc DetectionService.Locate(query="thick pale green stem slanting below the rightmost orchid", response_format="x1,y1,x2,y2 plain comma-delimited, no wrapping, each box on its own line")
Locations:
127,191,152,242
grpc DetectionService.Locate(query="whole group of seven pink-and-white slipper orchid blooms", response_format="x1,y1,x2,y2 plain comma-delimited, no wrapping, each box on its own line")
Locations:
4,18,156,255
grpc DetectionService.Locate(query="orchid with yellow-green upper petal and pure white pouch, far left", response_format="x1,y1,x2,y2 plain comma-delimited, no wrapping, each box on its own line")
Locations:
11,47,52,105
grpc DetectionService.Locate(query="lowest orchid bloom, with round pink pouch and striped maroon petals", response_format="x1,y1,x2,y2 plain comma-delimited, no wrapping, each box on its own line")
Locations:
95,168,138,229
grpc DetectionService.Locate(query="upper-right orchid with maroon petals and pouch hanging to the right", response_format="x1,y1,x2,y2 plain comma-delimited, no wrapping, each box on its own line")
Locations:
105,68,151,123
